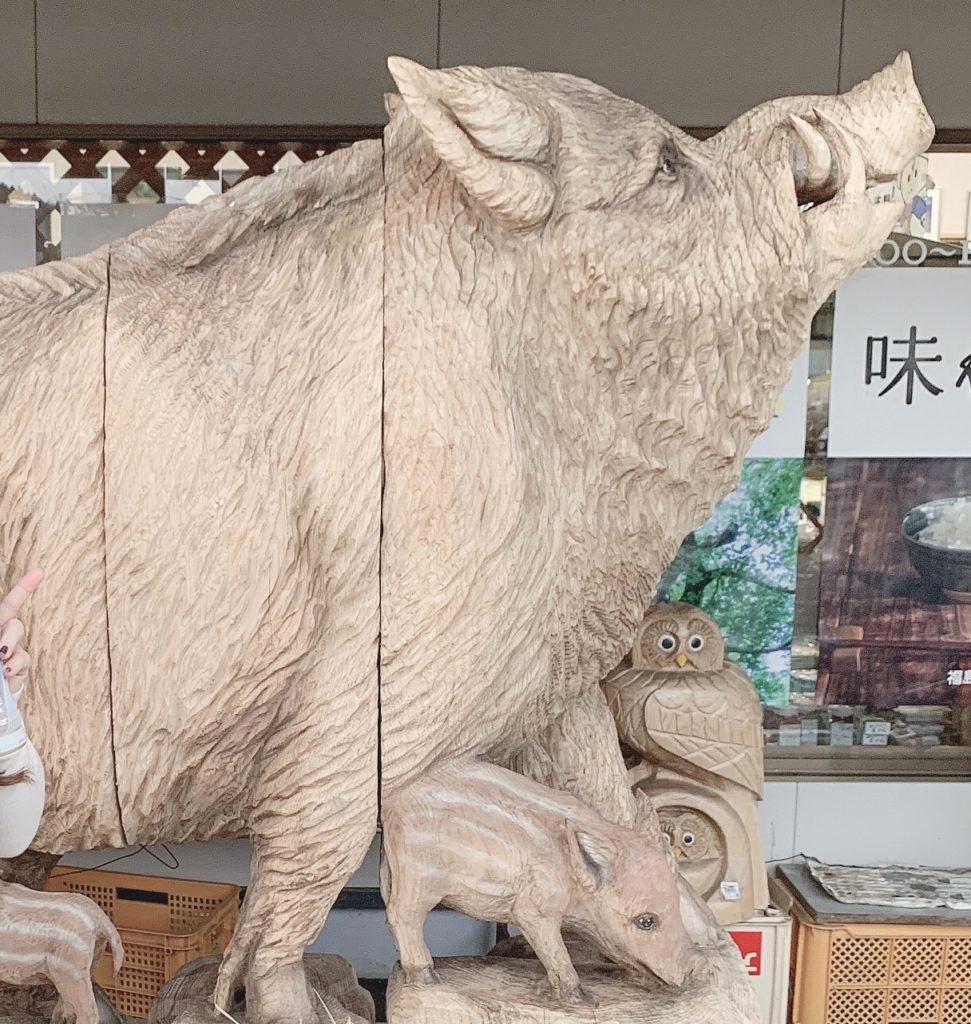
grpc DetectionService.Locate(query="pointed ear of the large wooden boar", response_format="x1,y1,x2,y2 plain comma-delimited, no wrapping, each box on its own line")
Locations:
388,57,555,231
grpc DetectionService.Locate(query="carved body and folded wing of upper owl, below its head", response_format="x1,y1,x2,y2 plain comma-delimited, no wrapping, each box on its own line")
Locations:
605,660,763,798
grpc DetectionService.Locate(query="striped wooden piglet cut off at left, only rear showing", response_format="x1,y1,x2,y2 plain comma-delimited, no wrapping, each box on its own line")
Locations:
0,882,124,1024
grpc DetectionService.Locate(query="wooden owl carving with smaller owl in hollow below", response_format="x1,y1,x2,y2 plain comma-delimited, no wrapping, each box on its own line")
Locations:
603,603,768,925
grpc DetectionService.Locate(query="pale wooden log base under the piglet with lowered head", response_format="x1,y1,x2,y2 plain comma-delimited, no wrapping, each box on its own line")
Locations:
387,956,756,1024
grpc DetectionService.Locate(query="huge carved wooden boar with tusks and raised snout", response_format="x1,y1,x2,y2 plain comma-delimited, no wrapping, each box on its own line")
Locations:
0,55,932,1022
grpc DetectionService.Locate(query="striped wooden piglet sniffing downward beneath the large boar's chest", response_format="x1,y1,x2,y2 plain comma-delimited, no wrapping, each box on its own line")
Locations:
381,759,699,1002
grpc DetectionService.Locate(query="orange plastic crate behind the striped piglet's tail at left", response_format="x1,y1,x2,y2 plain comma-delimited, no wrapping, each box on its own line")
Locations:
44,867,240,1018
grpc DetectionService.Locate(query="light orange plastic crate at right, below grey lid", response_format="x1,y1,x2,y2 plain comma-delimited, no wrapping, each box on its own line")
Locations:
793,910,971,1024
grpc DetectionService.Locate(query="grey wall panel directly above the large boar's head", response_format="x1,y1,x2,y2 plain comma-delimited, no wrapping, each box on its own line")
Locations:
441,0,841,127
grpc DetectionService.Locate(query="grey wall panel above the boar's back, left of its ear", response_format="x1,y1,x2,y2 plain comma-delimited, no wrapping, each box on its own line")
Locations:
38,0,437,125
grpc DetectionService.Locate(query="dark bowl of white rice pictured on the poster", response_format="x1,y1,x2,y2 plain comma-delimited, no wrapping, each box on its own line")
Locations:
900,496,971,604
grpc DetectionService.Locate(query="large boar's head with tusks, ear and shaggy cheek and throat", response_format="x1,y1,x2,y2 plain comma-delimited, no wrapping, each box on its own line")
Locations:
389,54,933,512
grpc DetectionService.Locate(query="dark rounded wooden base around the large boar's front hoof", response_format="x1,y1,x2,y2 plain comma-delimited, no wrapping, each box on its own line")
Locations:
147,953,375,1024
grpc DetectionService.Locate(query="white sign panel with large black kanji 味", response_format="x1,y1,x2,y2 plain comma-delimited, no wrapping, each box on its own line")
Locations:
829,267,971,459
